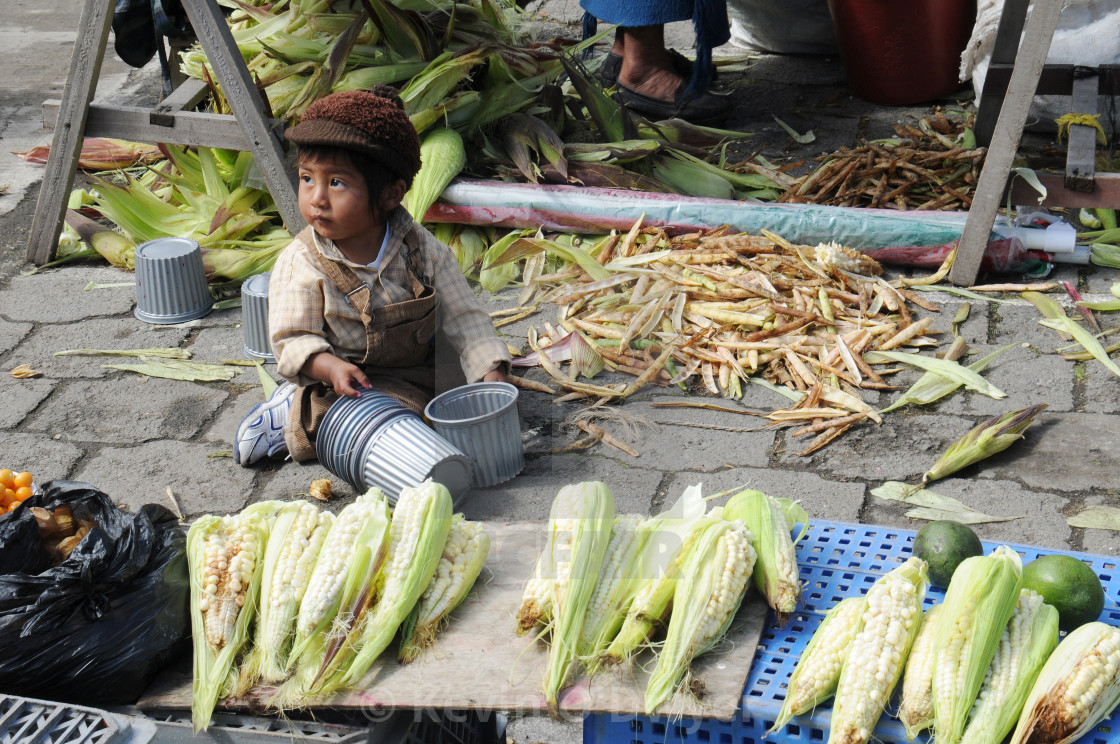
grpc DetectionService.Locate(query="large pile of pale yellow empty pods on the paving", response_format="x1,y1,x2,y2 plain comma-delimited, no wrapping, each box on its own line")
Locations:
515,222,940,455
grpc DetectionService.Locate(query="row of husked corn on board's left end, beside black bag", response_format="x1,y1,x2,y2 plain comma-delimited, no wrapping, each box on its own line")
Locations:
187,482,489,732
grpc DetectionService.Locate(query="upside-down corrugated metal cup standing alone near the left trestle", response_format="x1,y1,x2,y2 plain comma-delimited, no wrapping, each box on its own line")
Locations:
136,238,214,325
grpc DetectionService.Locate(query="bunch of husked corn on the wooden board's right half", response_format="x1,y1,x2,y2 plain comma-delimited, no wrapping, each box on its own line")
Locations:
516,482,808,714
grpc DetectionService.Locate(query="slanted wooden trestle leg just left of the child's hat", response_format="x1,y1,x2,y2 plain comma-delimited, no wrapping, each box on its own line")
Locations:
183,0,307,230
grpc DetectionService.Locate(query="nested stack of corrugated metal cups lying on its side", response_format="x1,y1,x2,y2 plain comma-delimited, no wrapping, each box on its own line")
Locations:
315,389,474,504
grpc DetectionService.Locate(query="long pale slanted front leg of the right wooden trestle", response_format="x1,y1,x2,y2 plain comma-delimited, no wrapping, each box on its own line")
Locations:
949,0,1062,287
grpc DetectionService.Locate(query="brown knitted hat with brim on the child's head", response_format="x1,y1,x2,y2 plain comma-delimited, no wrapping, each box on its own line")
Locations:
284,85,420,186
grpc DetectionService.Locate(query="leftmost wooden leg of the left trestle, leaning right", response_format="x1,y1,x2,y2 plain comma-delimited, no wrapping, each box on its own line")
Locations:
27,0,113,266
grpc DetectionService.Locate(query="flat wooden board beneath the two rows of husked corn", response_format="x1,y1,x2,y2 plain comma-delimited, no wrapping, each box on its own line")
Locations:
137,522,768,720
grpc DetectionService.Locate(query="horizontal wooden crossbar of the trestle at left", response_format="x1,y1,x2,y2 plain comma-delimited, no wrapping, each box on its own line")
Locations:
43,100,280,150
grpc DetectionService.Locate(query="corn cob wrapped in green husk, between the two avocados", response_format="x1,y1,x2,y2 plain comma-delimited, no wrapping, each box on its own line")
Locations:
933,546,1023,744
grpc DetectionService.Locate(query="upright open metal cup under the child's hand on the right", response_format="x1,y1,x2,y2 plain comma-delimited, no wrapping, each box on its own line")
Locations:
424,382,525,487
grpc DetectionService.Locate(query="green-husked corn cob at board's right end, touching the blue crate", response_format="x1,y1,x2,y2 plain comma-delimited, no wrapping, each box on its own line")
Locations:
724,491,809,623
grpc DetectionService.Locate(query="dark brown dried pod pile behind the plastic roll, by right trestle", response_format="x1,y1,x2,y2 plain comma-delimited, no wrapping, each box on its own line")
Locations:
777,113,988,210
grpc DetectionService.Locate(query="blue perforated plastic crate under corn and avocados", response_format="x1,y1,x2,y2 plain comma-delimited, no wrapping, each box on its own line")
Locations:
584,521,1120,744
